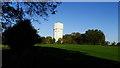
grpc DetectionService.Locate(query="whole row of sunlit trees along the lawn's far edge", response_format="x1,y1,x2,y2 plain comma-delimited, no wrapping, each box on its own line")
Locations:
41,29,108,45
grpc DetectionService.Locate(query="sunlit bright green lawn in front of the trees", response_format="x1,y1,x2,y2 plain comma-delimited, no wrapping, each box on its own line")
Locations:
35,44,120,61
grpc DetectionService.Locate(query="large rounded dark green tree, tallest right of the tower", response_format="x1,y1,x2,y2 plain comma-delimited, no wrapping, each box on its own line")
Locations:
85,29,105,45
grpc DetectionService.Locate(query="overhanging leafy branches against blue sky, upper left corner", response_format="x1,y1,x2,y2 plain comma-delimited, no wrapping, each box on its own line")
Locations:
1,2,61,29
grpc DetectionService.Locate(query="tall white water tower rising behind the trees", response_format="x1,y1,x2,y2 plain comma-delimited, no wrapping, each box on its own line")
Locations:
53,22,63,42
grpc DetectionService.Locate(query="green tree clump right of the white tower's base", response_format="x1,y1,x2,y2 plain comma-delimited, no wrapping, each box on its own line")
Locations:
63,30,105,45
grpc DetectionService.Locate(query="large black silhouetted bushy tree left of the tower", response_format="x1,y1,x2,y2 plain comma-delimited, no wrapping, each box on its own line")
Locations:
2,20,40,50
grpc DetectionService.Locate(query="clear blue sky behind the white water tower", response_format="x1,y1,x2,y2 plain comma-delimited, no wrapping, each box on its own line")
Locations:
34,2,118,42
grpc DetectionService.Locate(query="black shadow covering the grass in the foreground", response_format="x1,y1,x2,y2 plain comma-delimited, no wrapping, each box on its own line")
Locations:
2,47,119,68
